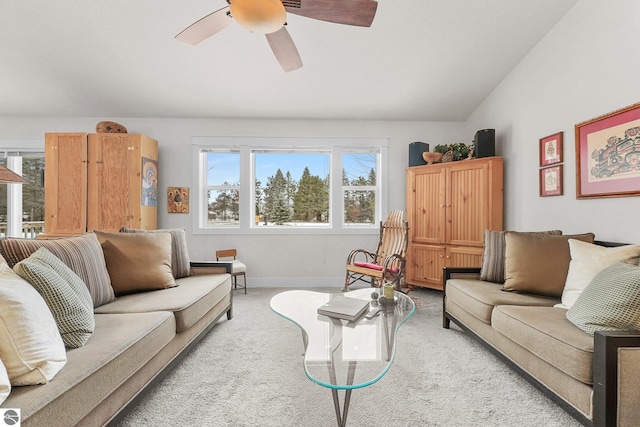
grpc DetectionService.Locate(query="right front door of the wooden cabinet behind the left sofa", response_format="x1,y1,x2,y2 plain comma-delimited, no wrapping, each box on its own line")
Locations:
87,133,133,232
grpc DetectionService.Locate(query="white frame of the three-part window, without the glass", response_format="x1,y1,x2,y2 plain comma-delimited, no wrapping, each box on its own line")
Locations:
192,136,389,234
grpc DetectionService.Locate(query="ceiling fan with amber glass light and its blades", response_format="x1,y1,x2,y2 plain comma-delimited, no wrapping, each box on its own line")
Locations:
176,0,378,72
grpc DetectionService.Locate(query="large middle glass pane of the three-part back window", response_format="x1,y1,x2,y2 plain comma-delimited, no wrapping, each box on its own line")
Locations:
254,151,331,227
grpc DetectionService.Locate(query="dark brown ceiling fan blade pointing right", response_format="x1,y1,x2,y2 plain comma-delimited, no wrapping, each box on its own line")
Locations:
282,0,378,27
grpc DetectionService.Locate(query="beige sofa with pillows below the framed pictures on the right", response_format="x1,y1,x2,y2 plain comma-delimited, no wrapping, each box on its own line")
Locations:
443,231,640,426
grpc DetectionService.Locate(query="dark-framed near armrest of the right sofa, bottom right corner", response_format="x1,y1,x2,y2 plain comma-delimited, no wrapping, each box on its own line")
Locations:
593,331,640,427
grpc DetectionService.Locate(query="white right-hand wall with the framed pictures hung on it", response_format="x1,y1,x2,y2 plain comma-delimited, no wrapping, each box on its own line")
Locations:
466,0,640,243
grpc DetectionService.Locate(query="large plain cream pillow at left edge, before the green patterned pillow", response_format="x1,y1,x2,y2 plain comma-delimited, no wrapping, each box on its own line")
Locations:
0,264,67,386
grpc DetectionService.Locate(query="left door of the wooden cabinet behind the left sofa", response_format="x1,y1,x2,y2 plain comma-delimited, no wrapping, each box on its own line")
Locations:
44,132,87,237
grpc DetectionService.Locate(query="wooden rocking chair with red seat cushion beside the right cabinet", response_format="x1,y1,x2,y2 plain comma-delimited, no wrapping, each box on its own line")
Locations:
342,211,409,292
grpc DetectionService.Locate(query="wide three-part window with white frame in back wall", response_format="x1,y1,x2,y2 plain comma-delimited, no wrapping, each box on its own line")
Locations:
193,137,388,233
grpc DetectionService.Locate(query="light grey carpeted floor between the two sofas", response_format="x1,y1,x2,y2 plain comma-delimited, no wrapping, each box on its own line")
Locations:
121,288,580,427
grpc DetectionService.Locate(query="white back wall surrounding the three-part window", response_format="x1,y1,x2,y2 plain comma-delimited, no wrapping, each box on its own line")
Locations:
0,117,473,287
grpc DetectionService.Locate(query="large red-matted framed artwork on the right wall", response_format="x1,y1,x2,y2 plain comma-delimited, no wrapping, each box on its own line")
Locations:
575,103,640,199
